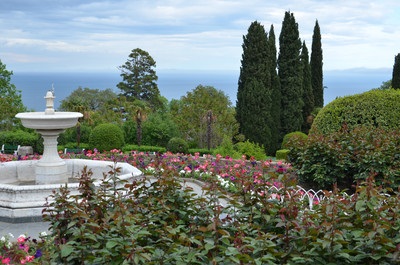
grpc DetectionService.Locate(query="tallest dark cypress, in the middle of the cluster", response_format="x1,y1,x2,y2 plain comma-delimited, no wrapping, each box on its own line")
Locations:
278,12,303,137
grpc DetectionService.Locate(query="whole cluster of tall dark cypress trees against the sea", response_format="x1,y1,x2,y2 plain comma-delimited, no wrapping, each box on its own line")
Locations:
236,12,324,154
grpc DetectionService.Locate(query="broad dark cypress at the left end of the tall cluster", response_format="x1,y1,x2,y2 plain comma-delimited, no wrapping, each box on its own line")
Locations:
236,21,272,152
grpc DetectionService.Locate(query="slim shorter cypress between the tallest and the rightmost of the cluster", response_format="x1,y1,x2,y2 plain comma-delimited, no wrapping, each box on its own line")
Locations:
300,42,314,134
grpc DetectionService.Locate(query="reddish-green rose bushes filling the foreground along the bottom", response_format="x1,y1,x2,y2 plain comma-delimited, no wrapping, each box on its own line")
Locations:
43,158,400,265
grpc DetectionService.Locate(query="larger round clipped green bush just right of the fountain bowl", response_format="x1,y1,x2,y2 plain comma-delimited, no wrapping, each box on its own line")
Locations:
89,123,124,152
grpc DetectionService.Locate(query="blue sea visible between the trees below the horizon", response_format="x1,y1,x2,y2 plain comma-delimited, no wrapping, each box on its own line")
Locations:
11,68,392,111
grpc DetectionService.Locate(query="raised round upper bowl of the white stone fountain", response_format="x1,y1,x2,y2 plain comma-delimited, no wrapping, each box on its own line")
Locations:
15,111,83,130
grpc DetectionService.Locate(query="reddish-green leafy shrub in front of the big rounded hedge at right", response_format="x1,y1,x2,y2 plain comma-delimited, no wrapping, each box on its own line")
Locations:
290,126,400,189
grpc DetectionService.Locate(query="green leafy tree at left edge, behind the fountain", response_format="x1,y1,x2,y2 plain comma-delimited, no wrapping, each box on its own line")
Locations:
0,60,26,130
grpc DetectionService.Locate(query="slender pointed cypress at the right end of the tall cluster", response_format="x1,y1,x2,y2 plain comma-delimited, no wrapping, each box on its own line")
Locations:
310,20,324,108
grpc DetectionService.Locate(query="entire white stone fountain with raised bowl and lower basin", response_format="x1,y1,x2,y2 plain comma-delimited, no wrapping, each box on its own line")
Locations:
0,91,142,222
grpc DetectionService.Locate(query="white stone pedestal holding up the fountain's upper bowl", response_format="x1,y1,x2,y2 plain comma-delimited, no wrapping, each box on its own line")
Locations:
35,130,68,184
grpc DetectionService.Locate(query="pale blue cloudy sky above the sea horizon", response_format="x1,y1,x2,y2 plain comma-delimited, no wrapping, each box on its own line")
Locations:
0,0,400,73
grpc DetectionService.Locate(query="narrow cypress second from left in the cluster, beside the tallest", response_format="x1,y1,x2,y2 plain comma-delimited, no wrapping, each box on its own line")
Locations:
268,25,281,155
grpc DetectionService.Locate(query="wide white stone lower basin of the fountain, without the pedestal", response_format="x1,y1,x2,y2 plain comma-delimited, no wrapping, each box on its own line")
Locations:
0,159,142,223
